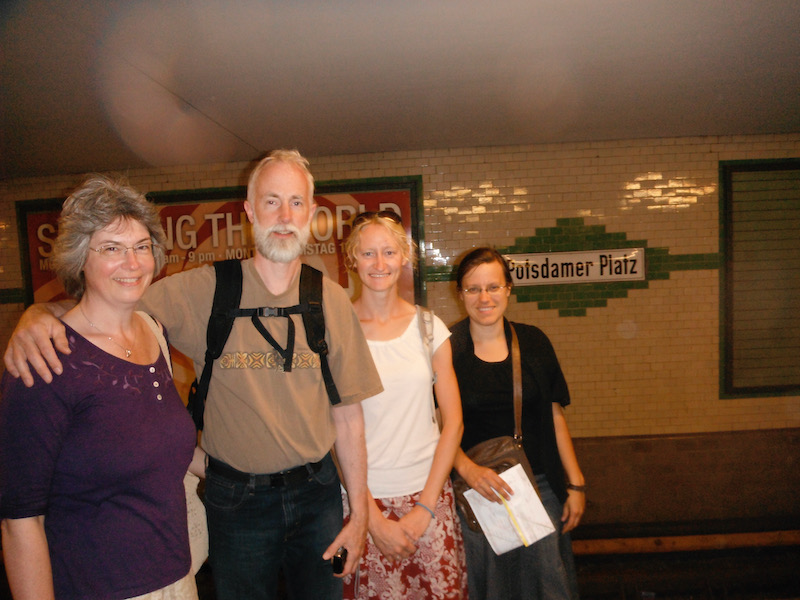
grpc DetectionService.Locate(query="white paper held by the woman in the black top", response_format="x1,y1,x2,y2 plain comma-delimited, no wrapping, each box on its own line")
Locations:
464,465,556,555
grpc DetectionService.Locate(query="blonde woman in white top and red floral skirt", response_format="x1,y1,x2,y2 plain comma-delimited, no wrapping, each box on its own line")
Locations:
344,211,467,600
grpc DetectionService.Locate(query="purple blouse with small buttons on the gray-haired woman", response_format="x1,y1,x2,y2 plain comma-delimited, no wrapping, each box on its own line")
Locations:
0,326,195,600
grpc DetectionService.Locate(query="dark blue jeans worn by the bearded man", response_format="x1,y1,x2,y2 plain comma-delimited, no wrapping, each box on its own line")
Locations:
205,455,342,600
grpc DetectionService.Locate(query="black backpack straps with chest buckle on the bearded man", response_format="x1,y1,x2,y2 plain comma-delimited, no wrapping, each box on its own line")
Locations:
187,259,341,430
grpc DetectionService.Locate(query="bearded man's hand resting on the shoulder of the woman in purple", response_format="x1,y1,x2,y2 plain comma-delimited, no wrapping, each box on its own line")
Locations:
3,301,75,387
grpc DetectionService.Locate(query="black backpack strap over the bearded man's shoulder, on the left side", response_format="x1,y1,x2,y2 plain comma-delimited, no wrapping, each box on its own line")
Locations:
187,259,242,430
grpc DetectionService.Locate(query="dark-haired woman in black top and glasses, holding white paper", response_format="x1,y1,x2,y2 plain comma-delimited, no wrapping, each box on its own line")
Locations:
450,247,586,600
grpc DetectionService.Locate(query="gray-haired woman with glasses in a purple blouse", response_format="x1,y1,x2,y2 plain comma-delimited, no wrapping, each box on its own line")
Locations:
0,176,202,600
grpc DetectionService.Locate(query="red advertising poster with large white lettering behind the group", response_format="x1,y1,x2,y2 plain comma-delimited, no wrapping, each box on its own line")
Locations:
17,177,425,399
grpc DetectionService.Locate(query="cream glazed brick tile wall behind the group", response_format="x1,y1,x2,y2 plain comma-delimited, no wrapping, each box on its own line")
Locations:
0,134,800,437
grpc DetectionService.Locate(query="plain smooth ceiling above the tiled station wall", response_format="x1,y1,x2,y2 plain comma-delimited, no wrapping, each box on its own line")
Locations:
0,0,800,179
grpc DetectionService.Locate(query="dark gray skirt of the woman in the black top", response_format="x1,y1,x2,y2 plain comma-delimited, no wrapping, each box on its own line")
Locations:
458,475,578,600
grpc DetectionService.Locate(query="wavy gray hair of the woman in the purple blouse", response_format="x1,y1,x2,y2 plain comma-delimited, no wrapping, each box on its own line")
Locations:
52,175,167,300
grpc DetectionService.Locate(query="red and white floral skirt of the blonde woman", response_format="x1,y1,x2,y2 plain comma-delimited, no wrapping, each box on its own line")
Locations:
342,479,467,600
